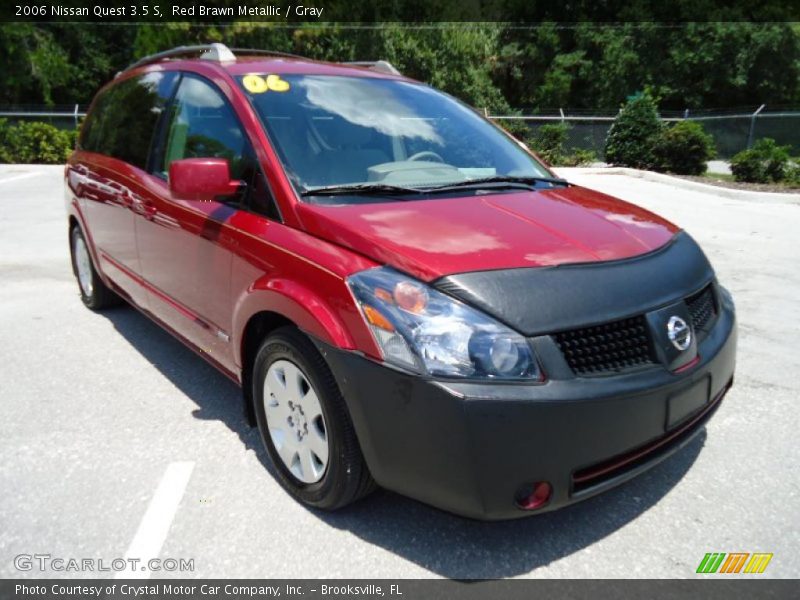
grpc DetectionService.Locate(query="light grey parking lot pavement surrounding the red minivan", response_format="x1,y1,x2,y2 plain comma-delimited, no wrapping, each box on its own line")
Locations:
0,165,800,578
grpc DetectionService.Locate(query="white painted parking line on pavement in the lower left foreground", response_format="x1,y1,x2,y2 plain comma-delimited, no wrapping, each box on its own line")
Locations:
114,462,194,579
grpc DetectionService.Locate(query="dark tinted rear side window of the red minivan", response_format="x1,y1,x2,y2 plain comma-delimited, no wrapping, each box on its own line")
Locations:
79,72,177,169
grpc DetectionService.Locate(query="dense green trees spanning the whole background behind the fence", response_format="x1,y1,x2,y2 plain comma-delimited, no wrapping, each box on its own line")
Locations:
0,20,800,113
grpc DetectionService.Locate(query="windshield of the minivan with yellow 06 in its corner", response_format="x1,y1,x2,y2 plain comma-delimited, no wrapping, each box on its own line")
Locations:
239,74,550,192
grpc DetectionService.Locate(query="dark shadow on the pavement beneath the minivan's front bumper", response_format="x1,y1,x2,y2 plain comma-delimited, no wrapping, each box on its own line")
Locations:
314,436,706,579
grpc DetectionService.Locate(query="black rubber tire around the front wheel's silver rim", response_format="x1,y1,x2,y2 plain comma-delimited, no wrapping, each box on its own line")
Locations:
252,327,375,510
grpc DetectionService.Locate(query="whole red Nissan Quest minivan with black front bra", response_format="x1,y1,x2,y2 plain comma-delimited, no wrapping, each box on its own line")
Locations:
66,44,736,519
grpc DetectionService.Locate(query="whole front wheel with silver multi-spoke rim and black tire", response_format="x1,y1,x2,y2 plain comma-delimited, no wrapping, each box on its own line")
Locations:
253,327,374,510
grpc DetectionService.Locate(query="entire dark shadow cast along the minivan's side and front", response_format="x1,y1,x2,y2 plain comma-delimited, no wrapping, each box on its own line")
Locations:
103,307,706,579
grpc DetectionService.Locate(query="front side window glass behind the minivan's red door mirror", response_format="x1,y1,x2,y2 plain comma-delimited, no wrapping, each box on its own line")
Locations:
156,74,279,220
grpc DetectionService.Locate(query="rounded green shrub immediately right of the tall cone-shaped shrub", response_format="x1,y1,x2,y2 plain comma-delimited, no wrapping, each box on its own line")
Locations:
653,121,716,175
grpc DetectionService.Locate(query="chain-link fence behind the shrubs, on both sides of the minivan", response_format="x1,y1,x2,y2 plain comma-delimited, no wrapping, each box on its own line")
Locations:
0,104,800,160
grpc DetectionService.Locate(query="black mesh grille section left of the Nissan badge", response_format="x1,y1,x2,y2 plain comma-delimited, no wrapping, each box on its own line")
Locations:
554,315,655,375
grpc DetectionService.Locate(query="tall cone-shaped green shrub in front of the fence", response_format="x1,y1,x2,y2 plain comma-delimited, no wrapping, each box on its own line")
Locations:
605,93,663,169
